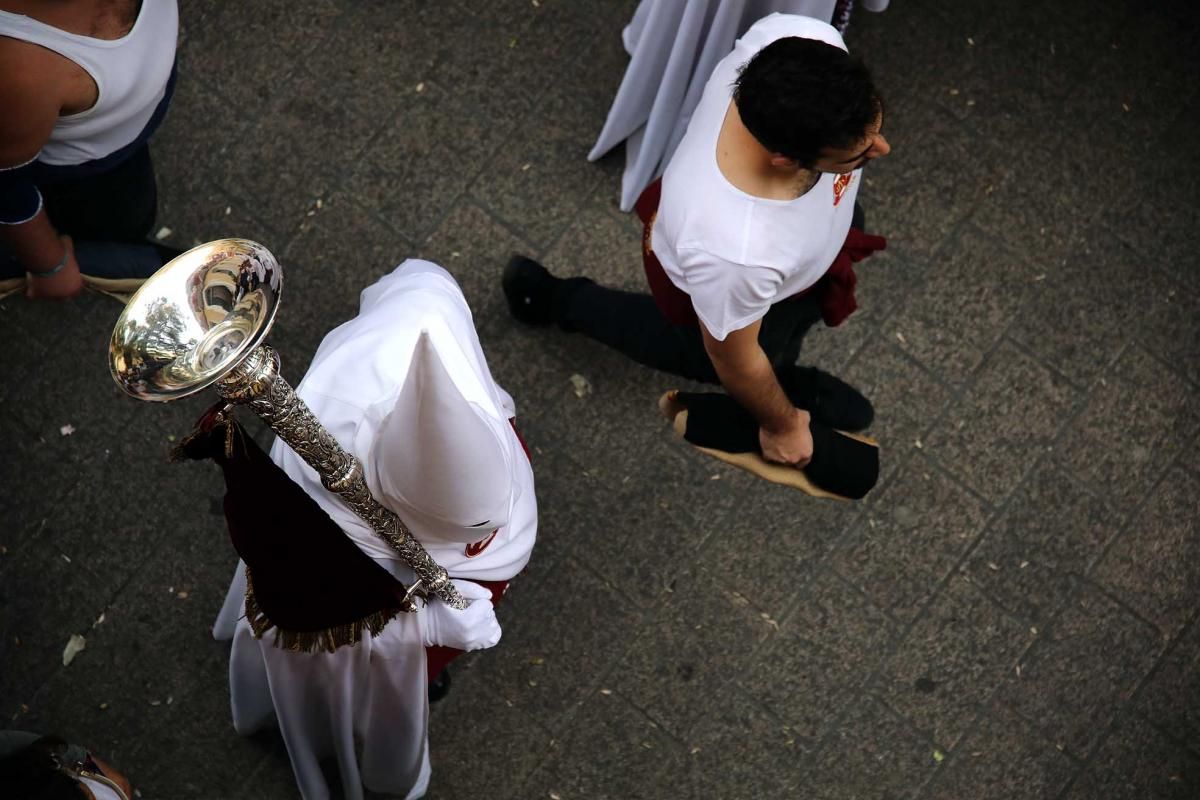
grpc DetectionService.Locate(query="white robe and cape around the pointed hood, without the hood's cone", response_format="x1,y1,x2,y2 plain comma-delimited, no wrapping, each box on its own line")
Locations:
214,259,538,800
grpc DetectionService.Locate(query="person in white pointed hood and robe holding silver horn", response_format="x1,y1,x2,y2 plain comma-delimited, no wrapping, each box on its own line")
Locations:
214,259,536,800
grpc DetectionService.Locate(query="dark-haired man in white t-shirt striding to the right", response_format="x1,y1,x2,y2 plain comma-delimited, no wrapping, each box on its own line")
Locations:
504,14,890,467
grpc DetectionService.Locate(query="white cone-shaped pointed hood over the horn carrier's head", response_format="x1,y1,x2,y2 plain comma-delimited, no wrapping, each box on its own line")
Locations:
366,330,512,545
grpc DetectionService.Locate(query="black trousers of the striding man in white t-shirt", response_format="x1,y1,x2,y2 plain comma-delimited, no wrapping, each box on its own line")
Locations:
556,282,821,384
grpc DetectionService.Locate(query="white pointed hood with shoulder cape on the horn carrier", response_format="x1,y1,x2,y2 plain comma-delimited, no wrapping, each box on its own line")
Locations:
271,259,536,568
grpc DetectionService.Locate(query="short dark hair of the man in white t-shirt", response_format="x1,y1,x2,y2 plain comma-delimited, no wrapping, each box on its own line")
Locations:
733,36,883,167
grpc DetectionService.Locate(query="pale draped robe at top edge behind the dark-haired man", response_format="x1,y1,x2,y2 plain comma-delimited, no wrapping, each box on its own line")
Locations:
588,0,888,211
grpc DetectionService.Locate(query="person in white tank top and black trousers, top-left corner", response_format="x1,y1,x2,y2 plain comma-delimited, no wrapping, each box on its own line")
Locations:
0,0,179,297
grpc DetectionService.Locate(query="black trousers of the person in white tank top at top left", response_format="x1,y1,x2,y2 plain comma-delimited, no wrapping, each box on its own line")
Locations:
38,144,158,243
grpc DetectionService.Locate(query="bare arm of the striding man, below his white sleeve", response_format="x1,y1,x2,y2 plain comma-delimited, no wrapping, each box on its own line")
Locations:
700,320,812,467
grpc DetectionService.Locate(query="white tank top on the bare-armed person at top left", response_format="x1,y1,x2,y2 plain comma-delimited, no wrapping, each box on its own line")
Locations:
0,0,179,166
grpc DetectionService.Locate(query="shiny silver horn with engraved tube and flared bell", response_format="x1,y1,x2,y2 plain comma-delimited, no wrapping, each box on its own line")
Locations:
108,239,467,610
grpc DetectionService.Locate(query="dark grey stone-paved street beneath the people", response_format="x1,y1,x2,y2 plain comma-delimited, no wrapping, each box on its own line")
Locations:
0,0,1200,800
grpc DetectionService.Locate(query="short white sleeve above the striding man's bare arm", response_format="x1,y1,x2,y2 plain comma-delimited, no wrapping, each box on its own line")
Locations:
678,249,782,342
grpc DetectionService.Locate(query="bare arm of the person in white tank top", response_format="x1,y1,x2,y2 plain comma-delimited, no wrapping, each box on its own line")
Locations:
0,40,83,297
